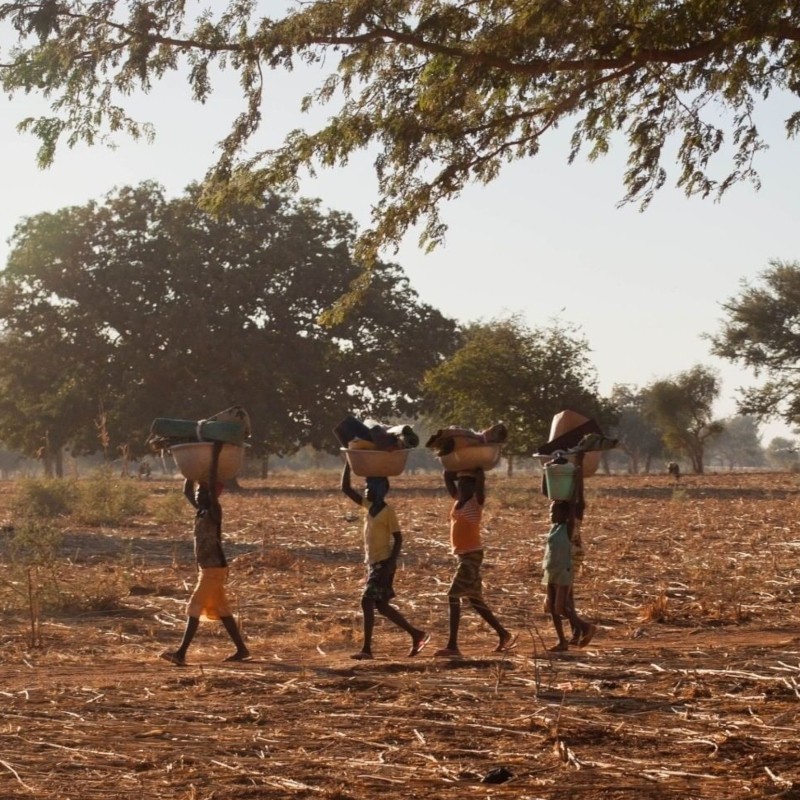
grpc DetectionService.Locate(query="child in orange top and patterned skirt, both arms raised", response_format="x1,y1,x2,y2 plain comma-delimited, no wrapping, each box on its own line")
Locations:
434,469,517,658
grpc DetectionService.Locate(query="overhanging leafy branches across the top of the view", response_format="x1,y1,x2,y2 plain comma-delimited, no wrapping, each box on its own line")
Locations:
0,0,800,257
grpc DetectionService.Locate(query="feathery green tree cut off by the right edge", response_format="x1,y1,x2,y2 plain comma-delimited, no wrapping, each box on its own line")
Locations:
708,260,800,425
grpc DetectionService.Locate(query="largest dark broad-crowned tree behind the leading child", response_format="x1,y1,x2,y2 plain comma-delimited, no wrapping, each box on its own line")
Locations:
0,183,456,468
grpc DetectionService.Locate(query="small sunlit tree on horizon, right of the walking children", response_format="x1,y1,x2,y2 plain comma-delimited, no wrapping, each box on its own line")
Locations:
645,366,724,474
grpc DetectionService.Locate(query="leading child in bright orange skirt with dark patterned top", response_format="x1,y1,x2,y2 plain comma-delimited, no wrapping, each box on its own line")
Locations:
161,442,250,667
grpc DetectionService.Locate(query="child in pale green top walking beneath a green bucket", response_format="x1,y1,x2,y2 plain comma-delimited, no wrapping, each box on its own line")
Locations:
542,500,597,652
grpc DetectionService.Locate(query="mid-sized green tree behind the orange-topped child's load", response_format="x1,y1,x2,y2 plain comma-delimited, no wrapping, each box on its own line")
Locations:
423,316,602,469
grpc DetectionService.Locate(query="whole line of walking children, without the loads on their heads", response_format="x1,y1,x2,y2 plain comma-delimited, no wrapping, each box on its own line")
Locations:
161,440,597,666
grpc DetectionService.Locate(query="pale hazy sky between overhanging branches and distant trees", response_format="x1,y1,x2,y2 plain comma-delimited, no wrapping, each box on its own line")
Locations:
0,53,800,444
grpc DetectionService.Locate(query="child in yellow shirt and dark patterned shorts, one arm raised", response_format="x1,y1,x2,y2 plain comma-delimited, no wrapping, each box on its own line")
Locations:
342,463,430,661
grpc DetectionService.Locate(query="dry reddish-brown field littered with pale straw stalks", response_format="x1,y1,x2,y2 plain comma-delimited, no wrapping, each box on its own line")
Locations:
0,473,800,800
